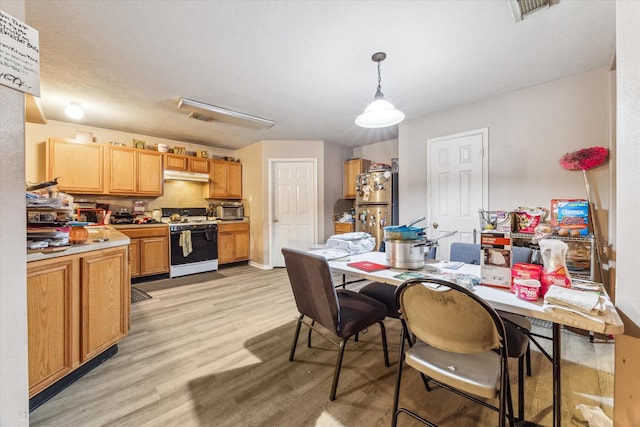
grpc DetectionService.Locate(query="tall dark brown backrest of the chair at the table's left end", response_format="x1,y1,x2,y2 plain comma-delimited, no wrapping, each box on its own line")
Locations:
282,248,339,332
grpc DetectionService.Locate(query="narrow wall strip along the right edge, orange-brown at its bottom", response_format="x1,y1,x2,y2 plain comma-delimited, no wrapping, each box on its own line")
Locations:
614,1,640,427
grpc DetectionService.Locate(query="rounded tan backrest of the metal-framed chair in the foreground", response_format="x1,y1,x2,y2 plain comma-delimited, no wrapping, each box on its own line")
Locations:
396,278,505,354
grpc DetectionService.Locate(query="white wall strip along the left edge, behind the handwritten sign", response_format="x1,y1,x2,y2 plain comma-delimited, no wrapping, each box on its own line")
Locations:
0,0,29,427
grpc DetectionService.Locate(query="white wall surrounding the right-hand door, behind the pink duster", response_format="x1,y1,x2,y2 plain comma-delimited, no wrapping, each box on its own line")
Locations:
399,68,610,229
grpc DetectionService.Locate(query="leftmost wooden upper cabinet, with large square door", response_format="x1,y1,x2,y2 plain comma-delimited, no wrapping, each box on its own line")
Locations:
46,138,105,194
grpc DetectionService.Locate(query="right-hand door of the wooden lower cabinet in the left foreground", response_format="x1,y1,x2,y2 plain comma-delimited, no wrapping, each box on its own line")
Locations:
80,247,131,362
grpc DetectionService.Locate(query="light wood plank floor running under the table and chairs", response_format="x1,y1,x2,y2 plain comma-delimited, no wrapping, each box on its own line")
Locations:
30,265,613,427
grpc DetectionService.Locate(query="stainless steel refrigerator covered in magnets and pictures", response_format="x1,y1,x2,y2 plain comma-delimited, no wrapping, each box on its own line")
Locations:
355,170,398,250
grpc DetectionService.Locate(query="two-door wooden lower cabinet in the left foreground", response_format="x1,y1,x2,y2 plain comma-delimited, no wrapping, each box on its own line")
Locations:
27,246,131,397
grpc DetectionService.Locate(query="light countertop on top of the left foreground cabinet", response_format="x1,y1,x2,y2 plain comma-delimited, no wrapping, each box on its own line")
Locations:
27,224,131,262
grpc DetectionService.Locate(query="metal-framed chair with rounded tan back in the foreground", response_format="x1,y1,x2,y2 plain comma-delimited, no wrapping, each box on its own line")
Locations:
392,278,514,427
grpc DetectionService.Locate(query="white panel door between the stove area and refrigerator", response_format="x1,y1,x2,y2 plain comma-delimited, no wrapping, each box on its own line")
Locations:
270,159,318,267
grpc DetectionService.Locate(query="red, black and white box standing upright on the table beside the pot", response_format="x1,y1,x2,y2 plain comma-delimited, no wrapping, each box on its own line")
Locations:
480,231,512,289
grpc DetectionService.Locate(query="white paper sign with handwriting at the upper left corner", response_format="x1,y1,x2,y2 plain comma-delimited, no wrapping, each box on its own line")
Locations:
0,10,40,97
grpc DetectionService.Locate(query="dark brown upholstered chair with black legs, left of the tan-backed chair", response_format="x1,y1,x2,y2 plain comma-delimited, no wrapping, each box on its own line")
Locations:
282,248,390,400
